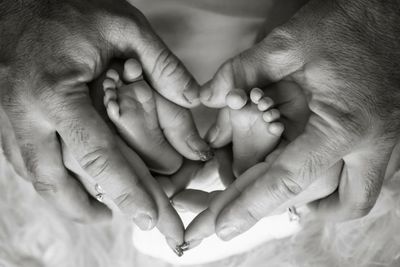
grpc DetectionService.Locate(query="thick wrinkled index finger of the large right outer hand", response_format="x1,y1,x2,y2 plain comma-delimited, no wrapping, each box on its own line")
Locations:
216,115,359,240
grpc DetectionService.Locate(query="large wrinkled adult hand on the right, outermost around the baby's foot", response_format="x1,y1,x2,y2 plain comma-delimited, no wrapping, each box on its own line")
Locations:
201,0,400,240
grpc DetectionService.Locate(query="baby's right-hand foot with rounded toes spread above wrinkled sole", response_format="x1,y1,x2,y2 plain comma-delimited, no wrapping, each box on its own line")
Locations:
226,88,284,177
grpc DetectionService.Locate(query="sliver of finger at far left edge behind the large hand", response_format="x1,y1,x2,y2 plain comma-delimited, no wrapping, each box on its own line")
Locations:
0,106,28,179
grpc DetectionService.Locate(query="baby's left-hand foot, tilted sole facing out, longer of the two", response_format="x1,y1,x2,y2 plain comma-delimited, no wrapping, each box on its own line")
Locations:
103,59,182,174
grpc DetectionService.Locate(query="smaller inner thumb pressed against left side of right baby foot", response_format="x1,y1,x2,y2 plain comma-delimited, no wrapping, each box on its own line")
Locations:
206,108,232,148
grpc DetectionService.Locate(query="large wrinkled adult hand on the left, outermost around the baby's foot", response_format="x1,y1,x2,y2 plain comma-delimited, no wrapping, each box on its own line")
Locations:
0,0,206,232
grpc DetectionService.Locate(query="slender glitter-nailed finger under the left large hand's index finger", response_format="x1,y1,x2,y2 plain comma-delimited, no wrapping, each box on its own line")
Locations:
118,140,184,253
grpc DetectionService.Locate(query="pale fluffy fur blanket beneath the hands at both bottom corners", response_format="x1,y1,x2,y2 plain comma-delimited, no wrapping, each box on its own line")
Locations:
0,151,400,267
